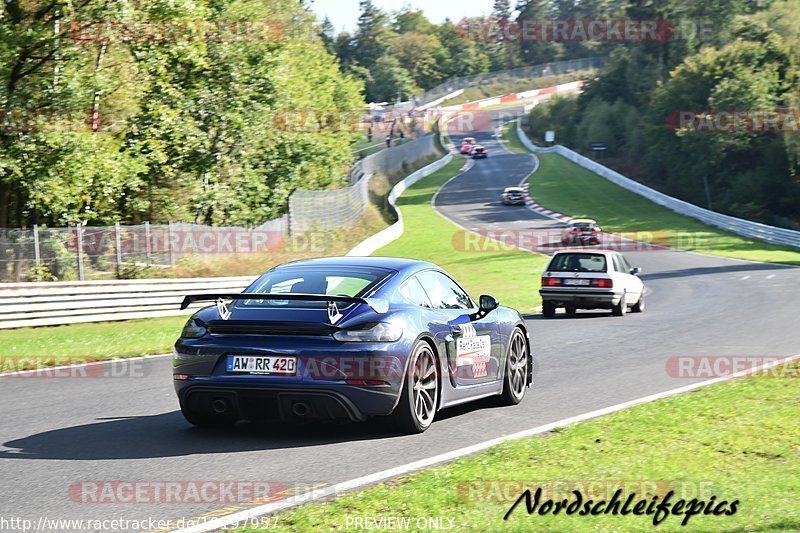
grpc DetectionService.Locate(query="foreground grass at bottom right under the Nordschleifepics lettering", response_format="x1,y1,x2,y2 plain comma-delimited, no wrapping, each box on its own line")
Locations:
241,360,800,533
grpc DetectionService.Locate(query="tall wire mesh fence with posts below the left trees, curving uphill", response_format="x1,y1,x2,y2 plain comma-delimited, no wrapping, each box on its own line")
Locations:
0,134,444,282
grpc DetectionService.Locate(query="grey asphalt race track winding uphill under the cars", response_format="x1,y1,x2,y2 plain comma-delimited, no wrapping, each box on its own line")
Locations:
0,110,800,521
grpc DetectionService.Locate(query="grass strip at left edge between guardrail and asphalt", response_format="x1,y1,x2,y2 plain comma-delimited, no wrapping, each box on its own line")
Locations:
0,315,188,364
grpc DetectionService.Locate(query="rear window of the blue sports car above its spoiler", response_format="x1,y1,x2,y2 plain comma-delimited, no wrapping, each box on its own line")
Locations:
236,265,392,309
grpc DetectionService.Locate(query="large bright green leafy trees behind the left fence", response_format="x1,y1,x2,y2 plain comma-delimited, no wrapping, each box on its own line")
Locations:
0,0,364,227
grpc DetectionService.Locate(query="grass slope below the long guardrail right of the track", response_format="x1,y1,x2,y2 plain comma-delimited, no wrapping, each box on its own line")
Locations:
504,123,800,265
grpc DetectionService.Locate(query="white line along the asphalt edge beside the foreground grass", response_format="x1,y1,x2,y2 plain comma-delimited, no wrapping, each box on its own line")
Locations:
173,354,800,533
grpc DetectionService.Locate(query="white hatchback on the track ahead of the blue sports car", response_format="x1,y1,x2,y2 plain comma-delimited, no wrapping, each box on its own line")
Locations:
539,250,645,317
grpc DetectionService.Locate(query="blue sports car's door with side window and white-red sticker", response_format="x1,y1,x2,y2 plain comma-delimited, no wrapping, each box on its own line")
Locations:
417,270,503,387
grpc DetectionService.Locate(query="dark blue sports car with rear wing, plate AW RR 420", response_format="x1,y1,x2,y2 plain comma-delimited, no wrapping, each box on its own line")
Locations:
173,257,533,433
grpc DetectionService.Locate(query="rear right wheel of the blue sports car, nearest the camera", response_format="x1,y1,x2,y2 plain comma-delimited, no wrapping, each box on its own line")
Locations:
389,341,439,435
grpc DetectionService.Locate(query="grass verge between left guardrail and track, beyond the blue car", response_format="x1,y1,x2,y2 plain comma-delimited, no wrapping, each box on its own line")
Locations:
375,157,547,313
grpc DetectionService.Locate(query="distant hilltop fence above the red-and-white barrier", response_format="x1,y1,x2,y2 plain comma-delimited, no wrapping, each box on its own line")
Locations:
414,57,606,107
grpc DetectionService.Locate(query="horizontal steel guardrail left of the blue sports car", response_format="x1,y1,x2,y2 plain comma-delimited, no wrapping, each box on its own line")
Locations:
0,276,255,329
